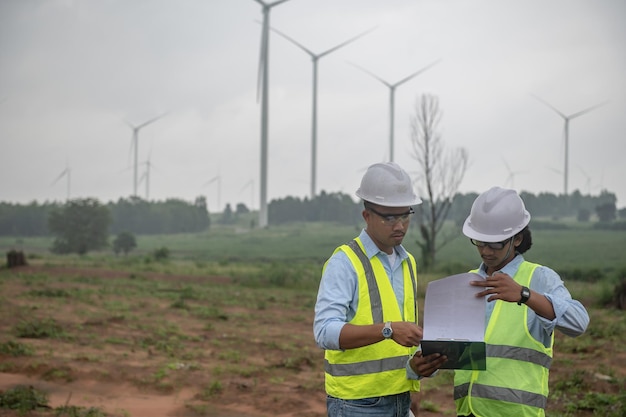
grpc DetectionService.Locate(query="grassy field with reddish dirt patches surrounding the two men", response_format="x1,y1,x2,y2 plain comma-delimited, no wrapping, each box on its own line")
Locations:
0,219,626,417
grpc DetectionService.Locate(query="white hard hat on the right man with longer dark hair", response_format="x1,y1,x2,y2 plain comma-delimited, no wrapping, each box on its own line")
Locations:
463,187,530,242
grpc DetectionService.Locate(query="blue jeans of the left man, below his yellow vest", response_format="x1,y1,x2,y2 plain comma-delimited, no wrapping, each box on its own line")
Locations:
326,392,411,417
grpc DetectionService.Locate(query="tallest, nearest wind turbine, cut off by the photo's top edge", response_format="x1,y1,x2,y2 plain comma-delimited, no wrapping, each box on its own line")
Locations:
254,0,288,228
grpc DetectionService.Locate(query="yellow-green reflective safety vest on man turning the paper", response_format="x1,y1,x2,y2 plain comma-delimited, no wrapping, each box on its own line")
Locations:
454,261,554,417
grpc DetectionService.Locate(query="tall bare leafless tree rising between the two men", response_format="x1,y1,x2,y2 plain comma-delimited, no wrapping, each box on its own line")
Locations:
411,94,468,270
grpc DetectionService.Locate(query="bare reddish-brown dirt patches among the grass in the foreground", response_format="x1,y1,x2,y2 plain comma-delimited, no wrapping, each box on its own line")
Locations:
0,266,626,417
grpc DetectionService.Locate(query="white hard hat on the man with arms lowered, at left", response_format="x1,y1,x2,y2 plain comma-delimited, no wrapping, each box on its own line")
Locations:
356,162,422,207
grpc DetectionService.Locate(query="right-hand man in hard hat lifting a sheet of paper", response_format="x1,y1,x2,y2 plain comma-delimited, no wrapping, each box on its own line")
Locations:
454,187,589,417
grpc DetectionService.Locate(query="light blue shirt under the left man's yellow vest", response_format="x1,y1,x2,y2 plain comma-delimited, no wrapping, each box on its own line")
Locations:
313,229,408,350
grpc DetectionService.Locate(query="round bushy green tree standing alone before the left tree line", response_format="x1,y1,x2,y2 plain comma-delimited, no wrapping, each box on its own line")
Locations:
48,198,111,255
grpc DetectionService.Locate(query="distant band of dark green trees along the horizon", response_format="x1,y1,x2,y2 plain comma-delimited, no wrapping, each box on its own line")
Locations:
0,191,626,237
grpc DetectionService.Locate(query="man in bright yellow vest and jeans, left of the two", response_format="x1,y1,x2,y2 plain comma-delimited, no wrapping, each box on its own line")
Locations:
313,162,445,417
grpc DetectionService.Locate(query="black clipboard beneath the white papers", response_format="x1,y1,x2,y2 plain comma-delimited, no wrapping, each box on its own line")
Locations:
421,339,487,371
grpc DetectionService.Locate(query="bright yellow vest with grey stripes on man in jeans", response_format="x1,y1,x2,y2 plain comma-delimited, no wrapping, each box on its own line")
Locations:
324,238,419,400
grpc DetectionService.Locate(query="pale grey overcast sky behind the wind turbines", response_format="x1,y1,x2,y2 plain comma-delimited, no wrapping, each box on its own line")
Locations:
0,0,626,211
